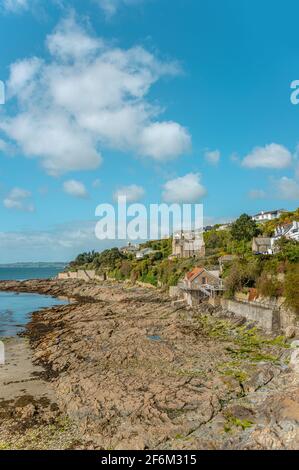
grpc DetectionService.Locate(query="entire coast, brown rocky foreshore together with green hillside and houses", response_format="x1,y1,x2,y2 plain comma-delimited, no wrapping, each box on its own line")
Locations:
0,209,299,450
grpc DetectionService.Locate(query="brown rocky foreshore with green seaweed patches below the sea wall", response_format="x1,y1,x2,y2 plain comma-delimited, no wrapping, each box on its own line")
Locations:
0,280,299,449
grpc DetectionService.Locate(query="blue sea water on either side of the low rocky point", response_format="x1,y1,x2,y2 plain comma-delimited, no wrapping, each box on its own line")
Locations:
0,264,67,338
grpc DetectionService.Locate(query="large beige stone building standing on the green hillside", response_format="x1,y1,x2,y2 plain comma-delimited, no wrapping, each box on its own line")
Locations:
172,231,205,258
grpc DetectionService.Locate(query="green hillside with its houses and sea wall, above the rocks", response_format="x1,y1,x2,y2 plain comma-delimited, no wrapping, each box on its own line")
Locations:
58,209,299,337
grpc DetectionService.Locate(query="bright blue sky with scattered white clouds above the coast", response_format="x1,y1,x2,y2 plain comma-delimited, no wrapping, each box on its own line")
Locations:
0,0,299,262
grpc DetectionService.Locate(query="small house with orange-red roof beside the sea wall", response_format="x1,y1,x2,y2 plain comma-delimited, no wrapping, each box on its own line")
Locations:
178,266,224,306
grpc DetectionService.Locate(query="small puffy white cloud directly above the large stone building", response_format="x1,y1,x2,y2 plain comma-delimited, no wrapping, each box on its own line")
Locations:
162,173,206,203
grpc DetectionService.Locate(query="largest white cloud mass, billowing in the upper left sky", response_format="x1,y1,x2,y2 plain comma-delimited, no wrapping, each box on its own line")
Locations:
0,16,191,175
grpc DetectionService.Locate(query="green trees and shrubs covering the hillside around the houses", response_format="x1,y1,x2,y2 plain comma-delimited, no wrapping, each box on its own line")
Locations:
69,209,299,312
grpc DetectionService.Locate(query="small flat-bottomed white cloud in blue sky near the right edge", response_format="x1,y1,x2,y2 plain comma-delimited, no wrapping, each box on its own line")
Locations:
242,144,292,169
